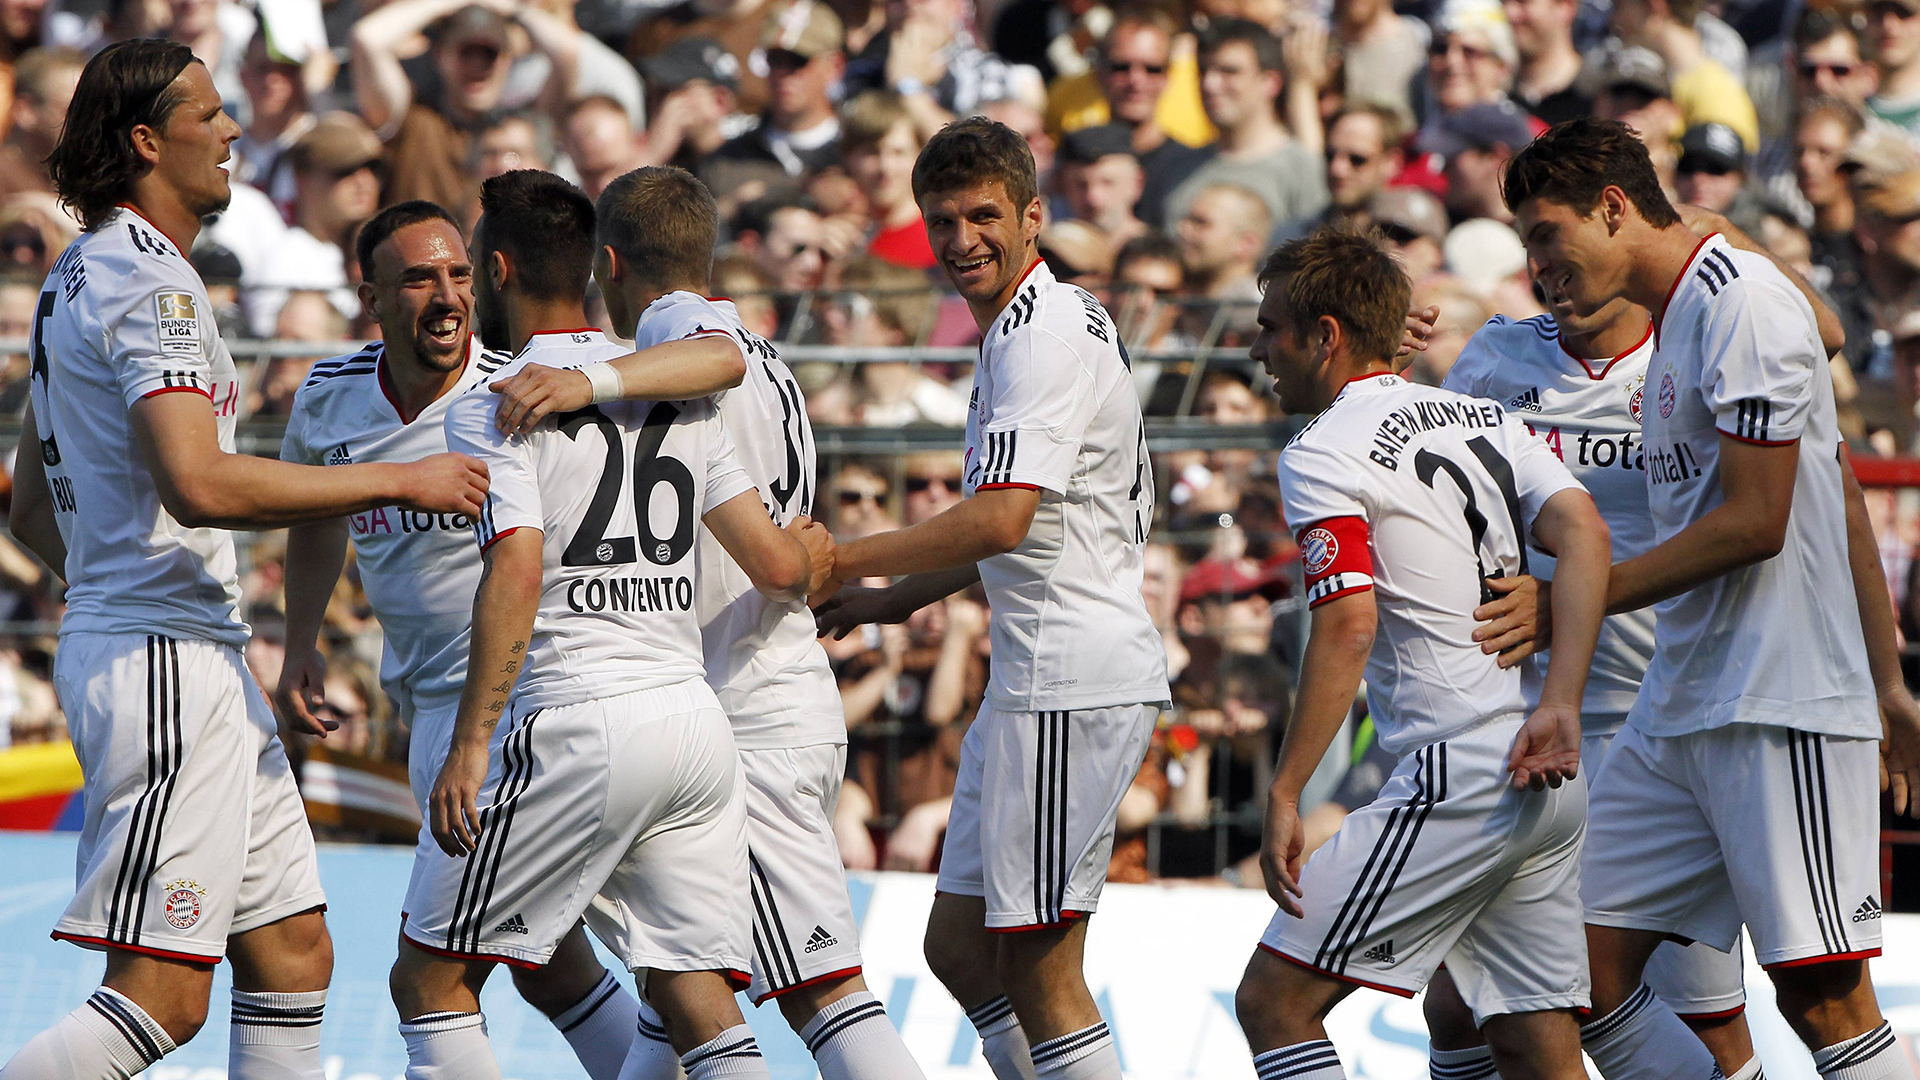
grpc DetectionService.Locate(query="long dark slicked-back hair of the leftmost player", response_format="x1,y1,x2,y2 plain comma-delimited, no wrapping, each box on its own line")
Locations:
46,38,198,229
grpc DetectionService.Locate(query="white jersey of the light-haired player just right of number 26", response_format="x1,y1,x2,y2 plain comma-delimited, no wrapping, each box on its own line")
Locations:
634,292,847,749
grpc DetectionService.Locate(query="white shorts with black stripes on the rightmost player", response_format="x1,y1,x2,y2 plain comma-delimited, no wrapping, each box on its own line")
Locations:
1584,724,1880,967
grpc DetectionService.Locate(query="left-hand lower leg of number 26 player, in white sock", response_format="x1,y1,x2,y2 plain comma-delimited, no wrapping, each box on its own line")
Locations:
388,936,499,1080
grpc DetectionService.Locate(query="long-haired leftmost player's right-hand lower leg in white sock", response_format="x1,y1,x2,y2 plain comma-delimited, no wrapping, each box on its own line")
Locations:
227,911,334,1080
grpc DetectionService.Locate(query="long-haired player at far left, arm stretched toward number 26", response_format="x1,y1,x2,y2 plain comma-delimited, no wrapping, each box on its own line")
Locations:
0,40,486,1080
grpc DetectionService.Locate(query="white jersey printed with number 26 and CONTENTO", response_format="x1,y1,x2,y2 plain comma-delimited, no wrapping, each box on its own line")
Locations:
447,331,753,715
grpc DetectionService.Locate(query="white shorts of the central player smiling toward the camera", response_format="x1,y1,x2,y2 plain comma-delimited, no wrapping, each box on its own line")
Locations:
935,703,1160,932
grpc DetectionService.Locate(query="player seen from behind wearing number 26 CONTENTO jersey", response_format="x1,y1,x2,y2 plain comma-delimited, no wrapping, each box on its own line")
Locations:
392,171,831,1080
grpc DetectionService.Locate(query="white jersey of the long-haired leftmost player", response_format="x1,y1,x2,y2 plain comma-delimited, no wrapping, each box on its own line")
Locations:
29,208,248,646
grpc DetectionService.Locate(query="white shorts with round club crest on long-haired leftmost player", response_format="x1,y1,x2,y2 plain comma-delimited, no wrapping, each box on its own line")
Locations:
54,634,326,963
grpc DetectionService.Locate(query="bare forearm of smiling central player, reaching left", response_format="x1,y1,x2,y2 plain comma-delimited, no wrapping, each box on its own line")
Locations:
833,486,1041,580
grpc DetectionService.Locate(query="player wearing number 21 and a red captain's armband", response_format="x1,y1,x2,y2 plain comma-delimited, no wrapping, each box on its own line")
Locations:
1236,231,1609,1080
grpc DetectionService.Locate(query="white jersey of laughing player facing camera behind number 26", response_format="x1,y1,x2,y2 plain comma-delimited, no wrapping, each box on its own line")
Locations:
280,336,509,719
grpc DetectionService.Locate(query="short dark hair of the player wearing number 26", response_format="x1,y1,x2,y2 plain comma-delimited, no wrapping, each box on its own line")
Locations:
472,169,593,300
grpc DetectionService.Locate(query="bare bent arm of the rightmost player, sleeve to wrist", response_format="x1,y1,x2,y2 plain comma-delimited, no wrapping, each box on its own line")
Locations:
1607,432,1799,615
